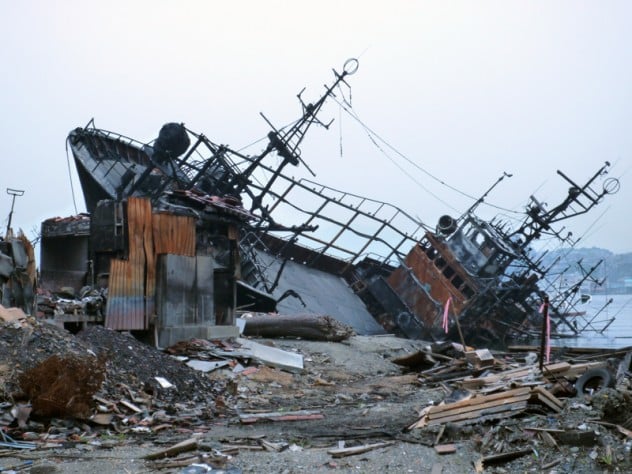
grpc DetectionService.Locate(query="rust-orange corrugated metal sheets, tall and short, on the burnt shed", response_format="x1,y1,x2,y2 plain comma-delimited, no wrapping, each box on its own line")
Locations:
105,197,195,330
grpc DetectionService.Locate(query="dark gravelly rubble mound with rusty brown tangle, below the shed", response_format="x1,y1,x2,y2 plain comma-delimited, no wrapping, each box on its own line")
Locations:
0,318,223,430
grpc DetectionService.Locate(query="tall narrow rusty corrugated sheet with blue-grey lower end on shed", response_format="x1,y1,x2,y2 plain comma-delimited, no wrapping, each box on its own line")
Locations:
105,198,155,330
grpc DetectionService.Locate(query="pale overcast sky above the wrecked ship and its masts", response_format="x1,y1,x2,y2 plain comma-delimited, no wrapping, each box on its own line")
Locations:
0,0,632,252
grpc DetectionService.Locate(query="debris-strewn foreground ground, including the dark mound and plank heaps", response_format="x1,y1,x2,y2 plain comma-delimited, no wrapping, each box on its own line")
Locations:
0,310,632,473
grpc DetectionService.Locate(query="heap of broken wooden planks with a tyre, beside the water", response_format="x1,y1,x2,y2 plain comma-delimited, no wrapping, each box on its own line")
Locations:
395,344,632,472
